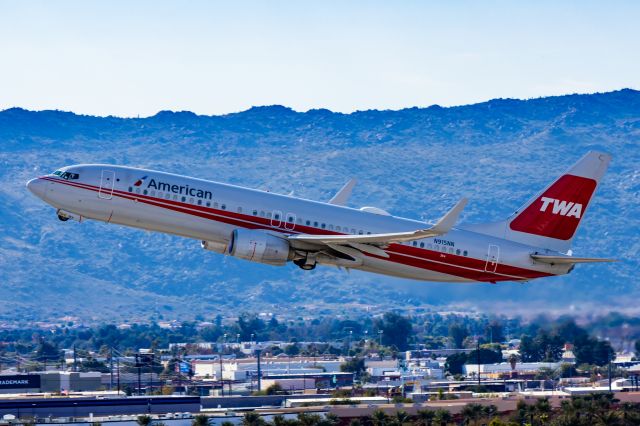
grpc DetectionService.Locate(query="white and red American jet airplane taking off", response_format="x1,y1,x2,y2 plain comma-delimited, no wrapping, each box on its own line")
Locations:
27,151,613,284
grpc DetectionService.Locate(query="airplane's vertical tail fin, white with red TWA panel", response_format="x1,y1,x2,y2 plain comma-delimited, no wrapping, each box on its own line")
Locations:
474,151,611,252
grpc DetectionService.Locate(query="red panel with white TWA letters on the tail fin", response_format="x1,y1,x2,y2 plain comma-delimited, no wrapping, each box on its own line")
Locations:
509,175,597,240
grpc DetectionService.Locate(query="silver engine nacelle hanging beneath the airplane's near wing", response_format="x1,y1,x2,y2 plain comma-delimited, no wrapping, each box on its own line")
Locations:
228,229,294,266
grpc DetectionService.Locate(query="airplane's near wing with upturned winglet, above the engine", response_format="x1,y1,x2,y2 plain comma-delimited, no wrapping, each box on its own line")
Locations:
289,198,467,248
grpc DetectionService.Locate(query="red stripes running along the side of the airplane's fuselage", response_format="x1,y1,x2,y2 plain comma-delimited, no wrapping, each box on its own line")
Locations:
41,176,553,282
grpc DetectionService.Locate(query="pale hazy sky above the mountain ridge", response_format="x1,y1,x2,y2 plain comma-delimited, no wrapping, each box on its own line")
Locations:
0,0,640,116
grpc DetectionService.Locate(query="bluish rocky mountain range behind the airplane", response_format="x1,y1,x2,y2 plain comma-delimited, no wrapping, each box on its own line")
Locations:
0,89,640,322
